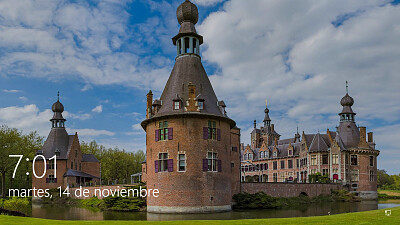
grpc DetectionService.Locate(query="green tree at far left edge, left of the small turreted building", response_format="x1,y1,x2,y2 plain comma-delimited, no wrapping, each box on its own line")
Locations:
0,126,43,197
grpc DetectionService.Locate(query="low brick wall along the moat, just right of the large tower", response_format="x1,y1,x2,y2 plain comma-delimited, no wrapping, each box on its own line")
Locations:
241,183,343,197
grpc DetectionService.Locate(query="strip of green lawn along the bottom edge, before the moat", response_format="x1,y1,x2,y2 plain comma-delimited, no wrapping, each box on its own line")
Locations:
0,207,400,225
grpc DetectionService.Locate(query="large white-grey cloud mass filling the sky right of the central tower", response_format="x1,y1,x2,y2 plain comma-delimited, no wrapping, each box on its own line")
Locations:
198,0,400,172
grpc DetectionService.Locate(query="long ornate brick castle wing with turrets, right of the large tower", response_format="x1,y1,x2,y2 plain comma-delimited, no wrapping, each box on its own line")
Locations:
241,85,379,199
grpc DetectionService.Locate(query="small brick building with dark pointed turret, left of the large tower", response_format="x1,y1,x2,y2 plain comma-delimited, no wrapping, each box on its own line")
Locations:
32,94,100,189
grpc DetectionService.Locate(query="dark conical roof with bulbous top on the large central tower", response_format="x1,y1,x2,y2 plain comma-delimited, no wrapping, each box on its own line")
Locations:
142,1,236,128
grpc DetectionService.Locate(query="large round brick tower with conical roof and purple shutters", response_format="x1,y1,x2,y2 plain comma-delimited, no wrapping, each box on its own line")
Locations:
141,0,240,213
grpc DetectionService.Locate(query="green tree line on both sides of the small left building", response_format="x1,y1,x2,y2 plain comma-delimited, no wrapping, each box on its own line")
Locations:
0,125,145,197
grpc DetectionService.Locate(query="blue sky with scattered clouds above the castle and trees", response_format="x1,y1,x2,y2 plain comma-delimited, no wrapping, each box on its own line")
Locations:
0,0,400,173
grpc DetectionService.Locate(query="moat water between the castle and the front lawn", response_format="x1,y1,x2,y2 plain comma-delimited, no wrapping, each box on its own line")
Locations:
32,200,400,220
